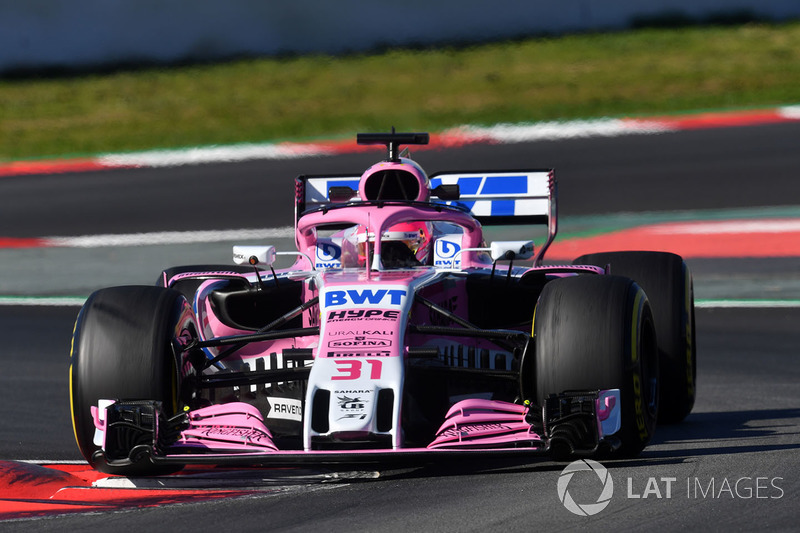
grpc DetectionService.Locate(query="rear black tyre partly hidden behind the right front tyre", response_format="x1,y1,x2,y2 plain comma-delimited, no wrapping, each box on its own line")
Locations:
575,252,697,423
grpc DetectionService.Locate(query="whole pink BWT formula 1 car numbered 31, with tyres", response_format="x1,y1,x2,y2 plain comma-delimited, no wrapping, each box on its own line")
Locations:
70,132,695,475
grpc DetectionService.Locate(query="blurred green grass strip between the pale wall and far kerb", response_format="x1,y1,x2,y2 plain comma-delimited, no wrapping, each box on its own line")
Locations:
0,23,800,160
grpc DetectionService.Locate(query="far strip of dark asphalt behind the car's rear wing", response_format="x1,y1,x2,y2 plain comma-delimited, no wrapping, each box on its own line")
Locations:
0,122,800,237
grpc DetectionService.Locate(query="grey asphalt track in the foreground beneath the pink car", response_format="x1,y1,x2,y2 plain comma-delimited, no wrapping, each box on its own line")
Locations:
0,308,800,532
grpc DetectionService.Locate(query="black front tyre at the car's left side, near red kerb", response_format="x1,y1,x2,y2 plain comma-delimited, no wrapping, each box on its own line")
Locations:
70,286,196,475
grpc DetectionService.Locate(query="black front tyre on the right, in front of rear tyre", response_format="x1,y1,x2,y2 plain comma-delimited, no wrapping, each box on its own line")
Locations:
533,275,658,457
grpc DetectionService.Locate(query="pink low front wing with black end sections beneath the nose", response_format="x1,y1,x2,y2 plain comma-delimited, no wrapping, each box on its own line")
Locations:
92,389,621,471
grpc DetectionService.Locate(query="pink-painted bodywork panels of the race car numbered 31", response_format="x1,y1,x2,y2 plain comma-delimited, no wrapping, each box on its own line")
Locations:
92,155,618,462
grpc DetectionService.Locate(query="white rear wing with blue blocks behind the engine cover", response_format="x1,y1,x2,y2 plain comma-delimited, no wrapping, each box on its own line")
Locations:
295,169,558,264
